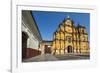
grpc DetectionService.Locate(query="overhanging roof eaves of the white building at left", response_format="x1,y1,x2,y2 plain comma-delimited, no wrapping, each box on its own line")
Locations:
22,10,42,41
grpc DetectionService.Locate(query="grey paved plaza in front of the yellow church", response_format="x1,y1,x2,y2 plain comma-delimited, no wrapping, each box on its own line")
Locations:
23,54,90,62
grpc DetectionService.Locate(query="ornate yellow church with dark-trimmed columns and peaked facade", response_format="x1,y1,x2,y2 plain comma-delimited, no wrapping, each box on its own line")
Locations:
51,16,90,54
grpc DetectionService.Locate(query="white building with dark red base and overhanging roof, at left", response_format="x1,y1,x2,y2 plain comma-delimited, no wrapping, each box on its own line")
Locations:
21,10,42,58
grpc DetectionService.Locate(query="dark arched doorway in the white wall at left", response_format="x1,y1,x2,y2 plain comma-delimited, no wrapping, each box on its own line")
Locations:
22,32,28,59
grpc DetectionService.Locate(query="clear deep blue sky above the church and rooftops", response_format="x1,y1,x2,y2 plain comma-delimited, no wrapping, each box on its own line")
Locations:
32,11,90,40
